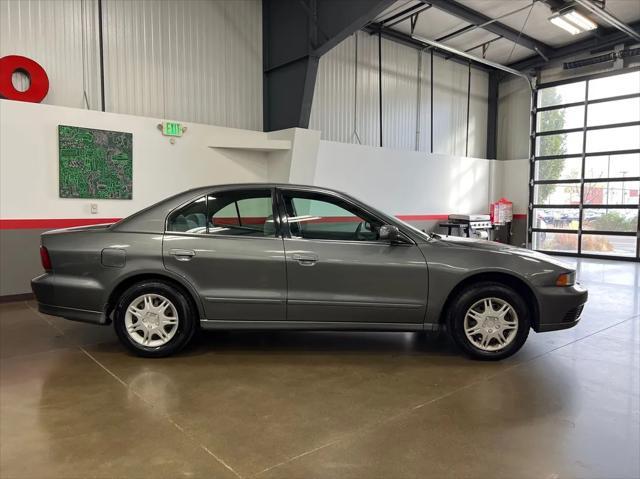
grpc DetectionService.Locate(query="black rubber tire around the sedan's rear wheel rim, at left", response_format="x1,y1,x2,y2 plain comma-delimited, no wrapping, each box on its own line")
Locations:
114,280,197,358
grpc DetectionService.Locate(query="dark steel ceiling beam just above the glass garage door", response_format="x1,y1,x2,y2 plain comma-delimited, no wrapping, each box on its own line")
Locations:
508,21,640,71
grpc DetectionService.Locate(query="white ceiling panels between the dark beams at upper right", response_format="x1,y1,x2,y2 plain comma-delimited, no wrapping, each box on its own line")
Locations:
376,0,640,64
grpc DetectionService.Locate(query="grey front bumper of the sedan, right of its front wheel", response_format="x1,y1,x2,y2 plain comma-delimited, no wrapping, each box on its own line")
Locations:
533,284,589,333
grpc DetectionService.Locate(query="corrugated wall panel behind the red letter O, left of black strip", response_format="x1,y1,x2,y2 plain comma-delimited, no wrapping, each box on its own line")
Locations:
0,0,100,108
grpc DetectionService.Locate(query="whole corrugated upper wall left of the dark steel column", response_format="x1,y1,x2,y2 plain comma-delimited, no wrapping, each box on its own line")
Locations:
0,0,262,130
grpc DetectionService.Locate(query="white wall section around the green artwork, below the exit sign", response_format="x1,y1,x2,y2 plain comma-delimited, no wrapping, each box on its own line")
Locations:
0,100,268,219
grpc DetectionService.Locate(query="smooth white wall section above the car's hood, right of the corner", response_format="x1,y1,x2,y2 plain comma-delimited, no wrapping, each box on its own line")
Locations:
313,141,499,216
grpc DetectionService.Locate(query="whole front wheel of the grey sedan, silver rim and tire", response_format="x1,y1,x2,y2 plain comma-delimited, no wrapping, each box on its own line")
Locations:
447,282,530,360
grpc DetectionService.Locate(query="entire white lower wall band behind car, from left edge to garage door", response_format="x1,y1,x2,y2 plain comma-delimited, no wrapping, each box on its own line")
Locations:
0,100,502,219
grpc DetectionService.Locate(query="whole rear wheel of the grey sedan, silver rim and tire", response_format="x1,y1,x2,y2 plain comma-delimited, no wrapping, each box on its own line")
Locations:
114,281,196,357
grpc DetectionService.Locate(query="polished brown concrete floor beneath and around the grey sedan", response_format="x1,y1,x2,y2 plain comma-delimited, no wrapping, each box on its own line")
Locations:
0,260,640,479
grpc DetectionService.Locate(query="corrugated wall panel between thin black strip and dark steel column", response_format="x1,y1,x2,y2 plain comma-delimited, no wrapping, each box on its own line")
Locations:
103,0,262,130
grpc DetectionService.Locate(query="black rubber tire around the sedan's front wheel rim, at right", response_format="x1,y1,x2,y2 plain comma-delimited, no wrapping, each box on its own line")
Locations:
447,282,531,361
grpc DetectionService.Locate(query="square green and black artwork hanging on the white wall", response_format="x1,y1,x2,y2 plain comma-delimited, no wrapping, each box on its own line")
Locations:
58,125,133,200
